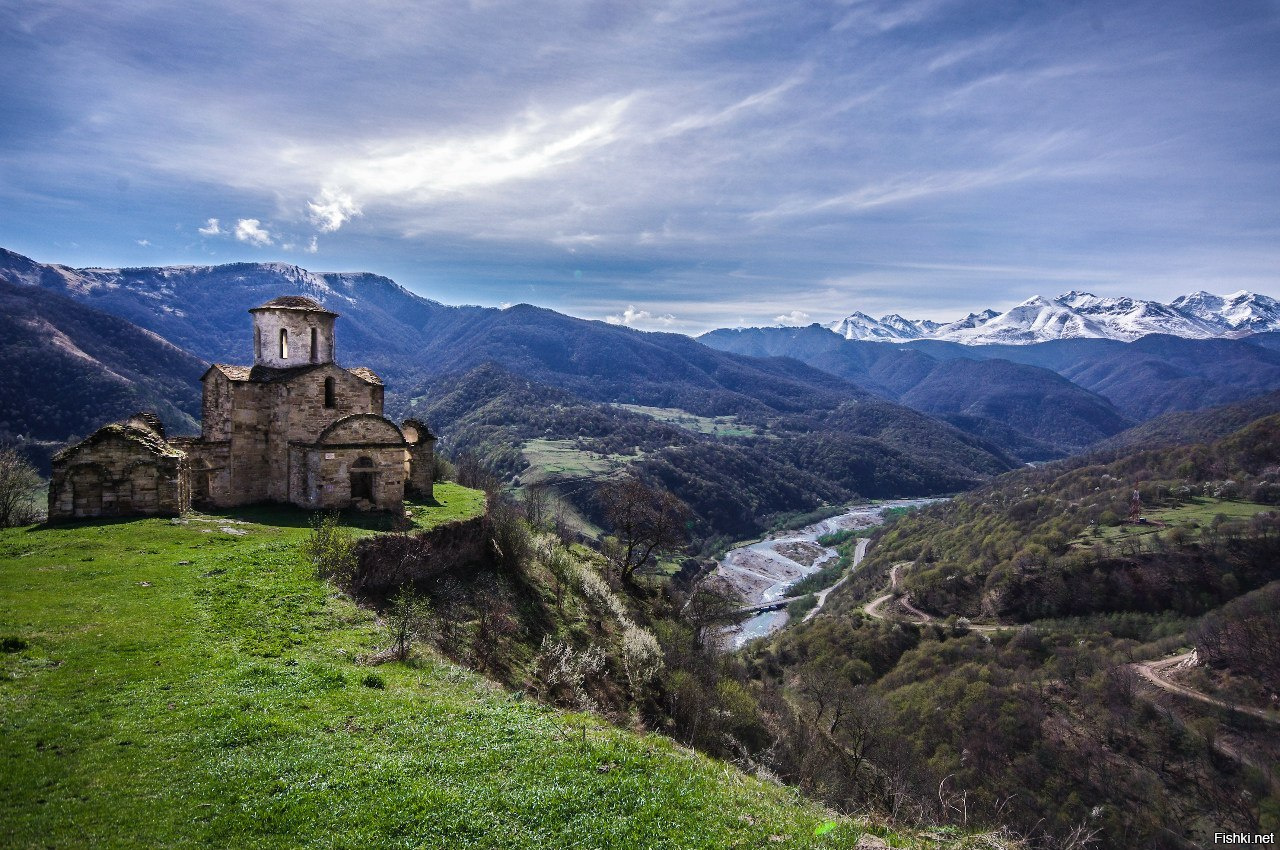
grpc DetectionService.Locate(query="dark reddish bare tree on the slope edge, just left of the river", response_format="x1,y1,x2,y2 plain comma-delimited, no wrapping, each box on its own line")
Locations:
598,475,690,581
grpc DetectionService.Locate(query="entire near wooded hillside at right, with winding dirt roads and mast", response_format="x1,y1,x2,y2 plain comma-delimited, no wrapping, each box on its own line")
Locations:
748,415,1280,850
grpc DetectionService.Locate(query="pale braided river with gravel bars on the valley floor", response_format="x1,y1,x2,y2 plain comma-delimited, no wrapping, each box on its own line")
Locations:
712,499,937,649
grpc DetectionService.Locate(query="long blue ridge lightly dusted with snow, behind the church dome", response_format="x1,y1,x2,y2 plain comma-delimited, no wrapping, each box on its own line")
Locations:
0,250,864,413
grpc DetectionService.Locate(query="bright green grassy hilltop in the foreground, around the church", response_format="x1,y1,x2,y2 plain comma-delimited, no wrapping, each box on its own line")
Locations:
0,486,952,849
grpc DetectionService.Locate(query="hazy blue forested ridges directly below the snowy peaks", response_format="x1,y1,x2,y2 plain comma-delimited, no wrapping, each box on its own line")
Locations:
699,325,1280,460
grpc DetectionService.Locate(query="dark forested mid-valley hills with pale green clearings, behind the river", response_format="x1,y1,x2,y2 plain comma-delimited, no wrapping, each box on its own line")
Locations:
397,364,1016,540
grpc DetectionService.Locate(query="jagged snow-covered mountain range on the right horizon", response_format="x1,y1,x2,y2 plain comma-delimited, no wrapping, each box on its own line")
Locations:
827,291,1280,346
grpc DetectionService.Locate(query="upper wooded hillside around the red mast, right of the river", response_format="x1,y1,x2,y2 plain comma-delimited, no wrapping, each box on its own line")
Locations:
872,415,1280,621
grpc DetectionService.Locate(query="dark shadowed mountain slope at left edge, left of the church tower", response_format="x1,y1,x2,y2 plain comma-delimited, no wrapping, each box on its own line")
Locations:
0,282,207,460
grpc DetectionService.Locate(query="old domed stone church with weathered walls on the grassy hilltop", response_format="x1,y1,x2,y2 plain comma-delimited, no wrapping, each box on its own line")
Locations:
49,296,435,521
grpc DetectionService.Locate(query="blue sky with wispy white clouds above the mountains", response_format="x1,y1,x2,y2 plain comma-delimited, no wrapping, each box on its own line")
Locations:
0,0,1280,333
